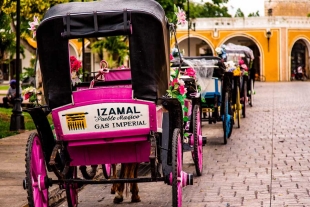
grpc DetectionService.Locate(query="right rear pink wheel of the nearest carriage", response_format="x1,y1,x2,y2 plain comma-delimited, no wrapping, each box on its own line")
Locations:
172,129,183,207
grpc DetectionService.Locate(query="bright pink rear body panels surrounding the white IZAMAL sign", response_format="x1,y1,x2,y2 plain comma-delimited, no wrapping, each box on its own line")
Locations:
52,83,162,166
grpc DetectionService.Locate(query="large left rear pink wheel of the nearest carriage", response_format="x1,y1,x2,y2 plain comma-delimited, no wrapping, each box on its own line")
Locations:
25,133,48,207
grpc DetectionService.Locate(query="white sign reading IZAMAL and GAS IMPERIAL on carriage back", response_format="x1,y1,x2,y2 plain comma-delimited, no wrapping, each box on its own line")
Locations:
58,103,150,134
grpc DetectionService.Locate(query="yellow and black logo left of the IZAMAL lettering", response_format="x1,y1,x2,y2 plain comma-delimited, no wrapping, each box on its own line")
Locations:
63,112,88,131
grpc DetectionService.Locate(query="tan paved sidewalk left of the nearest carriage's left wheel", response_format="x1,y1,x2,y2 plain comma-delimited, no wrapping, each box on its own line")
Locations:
0,130,65,207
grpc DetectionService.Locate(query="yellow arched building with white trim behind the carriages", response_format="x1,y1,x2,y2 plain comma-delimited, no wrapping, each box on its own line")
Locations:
171,16,310,81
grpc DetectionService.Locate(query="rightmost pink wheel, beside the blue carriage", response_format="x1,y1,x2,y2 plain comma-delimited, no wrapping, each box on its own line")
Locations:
193,105,203,176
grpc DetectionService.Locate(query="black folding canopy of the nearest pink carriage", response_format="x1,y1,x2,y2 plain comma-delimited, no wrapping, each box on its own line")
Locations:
37,0,170,109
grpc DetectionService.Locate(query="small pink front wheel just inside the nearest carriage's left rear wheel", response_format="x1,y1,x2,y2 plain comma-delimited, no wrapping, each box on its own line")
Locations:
66,167,78,207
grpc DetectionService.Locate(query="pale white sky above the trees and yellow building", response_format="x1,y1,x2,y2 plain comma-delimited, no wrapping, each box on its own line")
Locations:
193,0,265,17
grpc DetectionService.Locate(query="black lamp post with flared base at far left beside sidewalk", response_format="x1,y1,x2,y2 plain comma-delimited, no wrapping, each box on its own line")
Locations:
10,0,25,131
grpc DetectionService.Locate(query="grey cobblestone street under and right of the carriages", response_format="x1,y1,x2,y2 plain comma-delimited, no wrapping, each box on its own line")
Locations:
55,82,310,207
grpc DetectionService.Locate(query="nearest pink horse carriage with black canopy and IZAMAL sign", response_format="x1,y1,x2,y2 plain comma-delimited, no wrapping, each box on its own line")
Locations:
24,0,203,207
